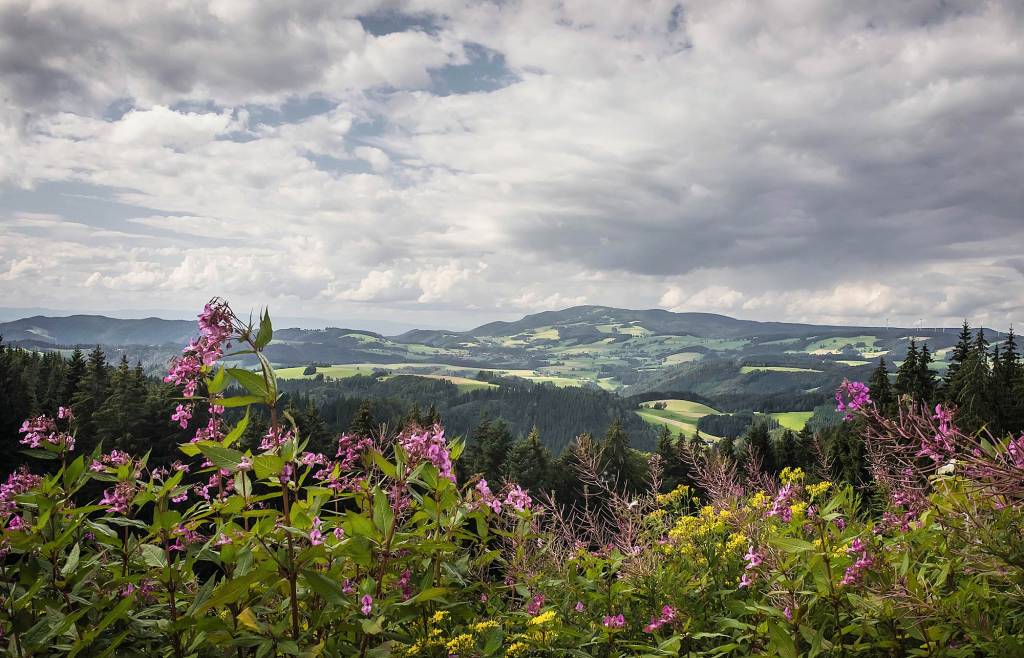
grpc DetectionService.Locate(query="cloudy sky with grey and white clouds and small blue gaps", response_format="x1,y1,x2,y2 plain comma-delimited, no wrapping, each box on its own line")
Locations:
0,0,1024,328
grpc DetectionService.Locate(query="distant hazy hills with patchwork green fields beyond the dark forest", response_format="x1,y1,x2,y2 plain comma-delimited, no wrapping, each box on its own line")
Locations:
0,306,1001,404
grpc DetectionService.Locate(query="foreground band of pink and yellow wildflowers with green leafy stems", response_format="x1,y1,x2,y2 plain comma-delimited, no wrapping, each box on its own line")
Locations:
0,300,1024,658
